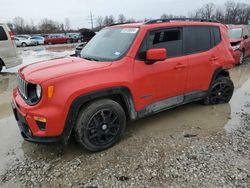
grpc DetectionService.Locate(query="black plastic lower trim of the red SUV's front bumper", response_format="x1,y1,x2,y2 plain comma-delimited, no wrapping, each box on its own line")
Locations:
11,102,62,144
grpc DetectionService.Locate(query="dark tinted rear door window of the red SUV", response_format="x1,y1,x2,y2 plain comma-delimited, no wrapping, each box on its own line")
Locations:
184,26,211,54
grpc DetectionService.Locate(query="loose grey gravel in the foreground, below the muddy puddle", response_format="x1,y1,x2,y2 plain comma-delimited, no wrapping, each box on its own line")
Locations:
1,104,250,187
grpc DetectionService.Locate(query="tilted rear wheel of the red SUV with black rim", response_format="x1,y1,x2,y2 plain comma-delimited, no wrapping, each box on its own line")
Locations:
203,77,234,105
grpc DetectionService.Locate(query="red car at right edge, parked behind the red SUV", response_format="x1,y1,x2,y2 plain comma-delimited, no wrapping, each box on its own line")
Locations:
228,25,250,64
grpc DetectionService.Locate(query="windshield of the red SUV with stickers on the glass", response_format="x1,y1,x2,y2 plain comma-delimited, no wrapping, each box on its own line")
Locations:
81,28,139,61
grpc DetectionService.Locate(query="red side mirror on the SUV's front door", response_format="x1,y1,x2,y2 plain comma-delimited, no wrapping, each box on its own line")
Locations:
146,48,167,64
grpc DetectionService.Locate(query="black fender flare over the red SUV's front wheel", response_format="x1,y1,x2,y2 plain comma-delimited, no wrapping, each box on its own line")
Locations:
62,87,137,144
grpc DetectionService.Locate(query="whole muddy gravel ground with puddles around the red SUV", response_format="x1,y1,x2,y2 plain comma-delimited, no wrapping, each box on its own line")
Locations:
0,48,250,188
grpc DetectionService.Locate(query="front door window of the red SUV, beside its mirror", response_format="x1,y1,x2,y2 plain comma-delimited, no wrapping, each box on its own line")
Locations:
147,28,183,57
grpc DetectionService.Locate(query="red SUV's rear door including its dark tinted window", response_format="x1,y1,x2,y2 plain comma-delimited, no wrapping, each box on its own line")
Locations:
184,26,219,93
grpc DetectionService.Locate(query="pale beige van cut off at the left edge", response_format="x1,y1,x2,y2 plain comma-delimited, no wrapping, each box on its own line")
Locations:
0,23,22,72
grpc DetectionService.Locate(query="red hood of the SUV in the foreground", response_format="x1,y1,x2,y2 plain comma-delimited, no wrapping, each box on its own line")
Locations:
19,57,111,84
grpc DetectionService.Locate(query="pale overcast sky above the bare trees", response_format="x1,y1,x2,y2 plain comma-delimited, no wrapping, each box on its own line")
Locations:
0,0,246,29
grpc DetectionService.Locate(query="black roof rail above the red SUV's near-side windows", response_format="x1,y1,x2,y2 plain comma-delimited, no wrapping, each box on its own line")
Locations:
145,18,220,24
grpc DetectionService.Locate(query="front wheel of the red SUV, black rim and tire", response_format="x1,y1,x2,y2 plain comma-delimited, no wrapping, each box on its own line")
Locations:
75,99,126,152
